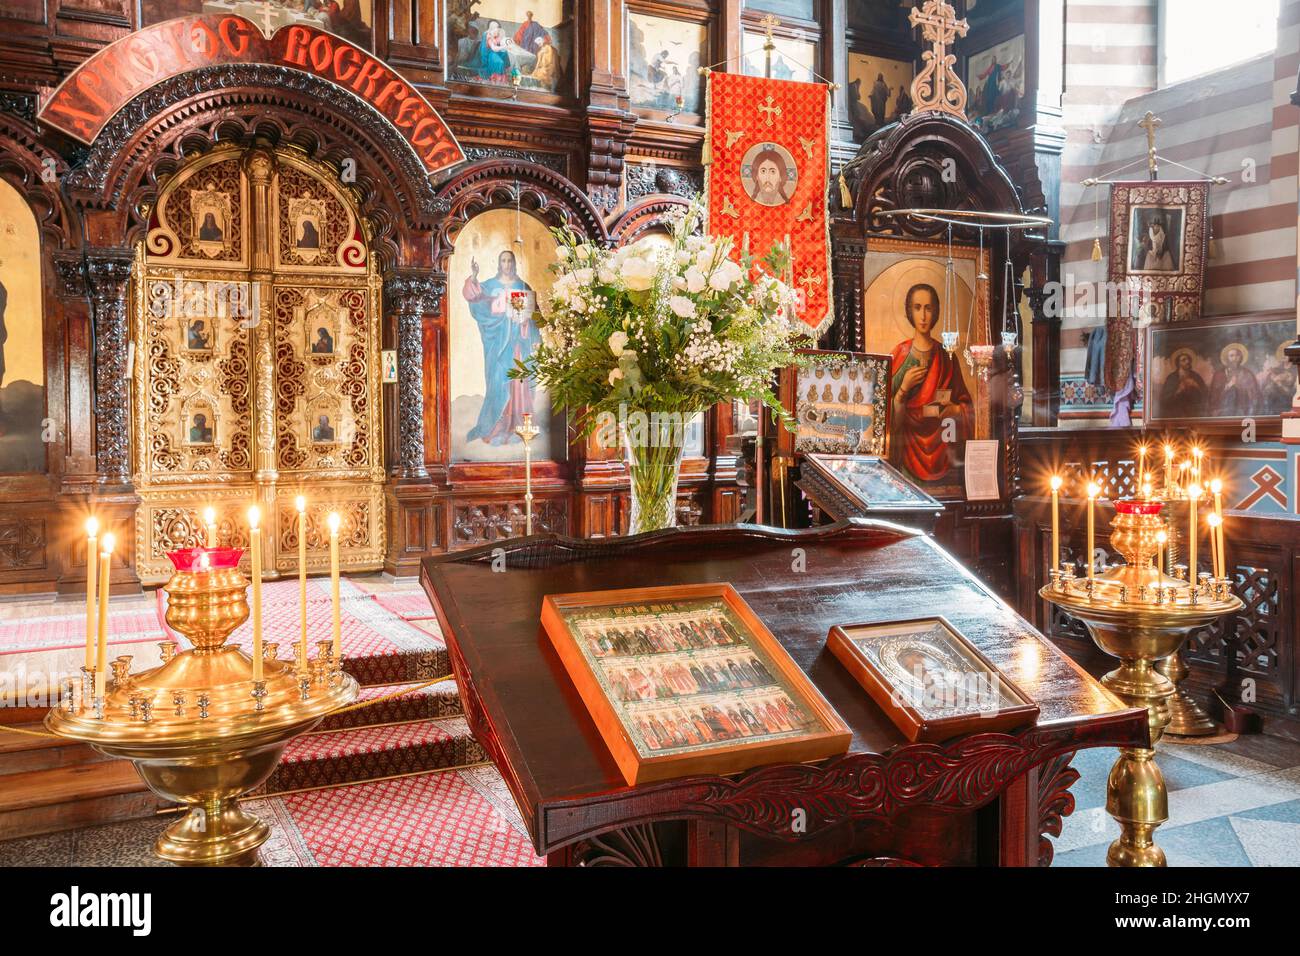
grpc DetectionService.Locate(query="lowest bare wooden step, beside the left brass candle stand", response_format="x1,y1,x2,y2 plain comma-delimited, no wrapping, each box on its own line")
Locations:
0,760,158,840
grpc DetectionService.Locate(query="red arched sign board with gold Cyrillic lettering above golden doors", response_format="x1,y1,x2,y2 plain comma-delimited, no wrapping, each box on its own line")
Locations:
38,14,465,176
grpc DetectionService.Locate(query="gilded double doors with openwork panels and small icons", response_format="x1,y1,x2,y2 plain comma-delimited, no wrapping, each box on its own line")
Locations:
133,150,384,581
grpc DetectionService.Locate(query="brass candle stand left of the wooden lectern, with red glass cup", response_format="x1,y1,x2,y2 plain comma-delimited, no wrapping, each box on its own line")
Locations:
46,548,358,866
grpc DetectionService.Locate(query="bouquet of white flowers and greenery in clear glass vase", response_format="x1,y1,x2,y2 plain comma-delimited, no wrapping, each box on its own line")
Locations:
511,203,810,532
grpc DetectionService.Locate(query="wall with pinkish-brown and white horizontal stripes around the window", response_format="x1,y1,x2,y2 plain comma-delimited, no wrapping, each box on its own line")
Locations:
1061,0,1300,420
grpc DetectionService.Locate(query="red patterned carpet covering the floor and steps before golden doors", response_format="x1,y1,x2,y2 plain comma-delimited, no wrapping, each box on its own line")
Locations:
0,578,543,866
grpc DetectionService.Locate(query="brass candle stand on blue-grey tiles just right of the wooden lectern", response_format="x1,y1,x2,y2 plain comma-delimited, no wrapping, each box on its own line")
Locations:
1039,499,1243,866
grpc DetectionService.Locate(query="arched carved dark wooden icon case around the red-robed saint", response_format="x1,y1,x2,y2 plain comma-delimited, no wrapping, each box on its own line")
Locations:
823,113,1049,593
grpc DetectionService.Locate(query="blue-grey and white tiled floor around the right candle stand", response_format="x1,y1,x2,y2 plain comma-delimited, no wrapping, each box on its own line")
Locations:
1053,736,1300,866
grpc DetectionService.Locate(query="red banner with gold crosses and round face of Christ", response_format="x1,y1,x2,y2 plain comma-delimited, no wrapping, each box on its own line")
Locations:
705,73,835,332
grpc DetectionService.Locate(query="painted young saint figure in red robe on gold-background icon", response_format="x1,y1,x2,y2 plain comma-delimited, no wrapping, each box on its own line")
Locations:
889,282,974,481
